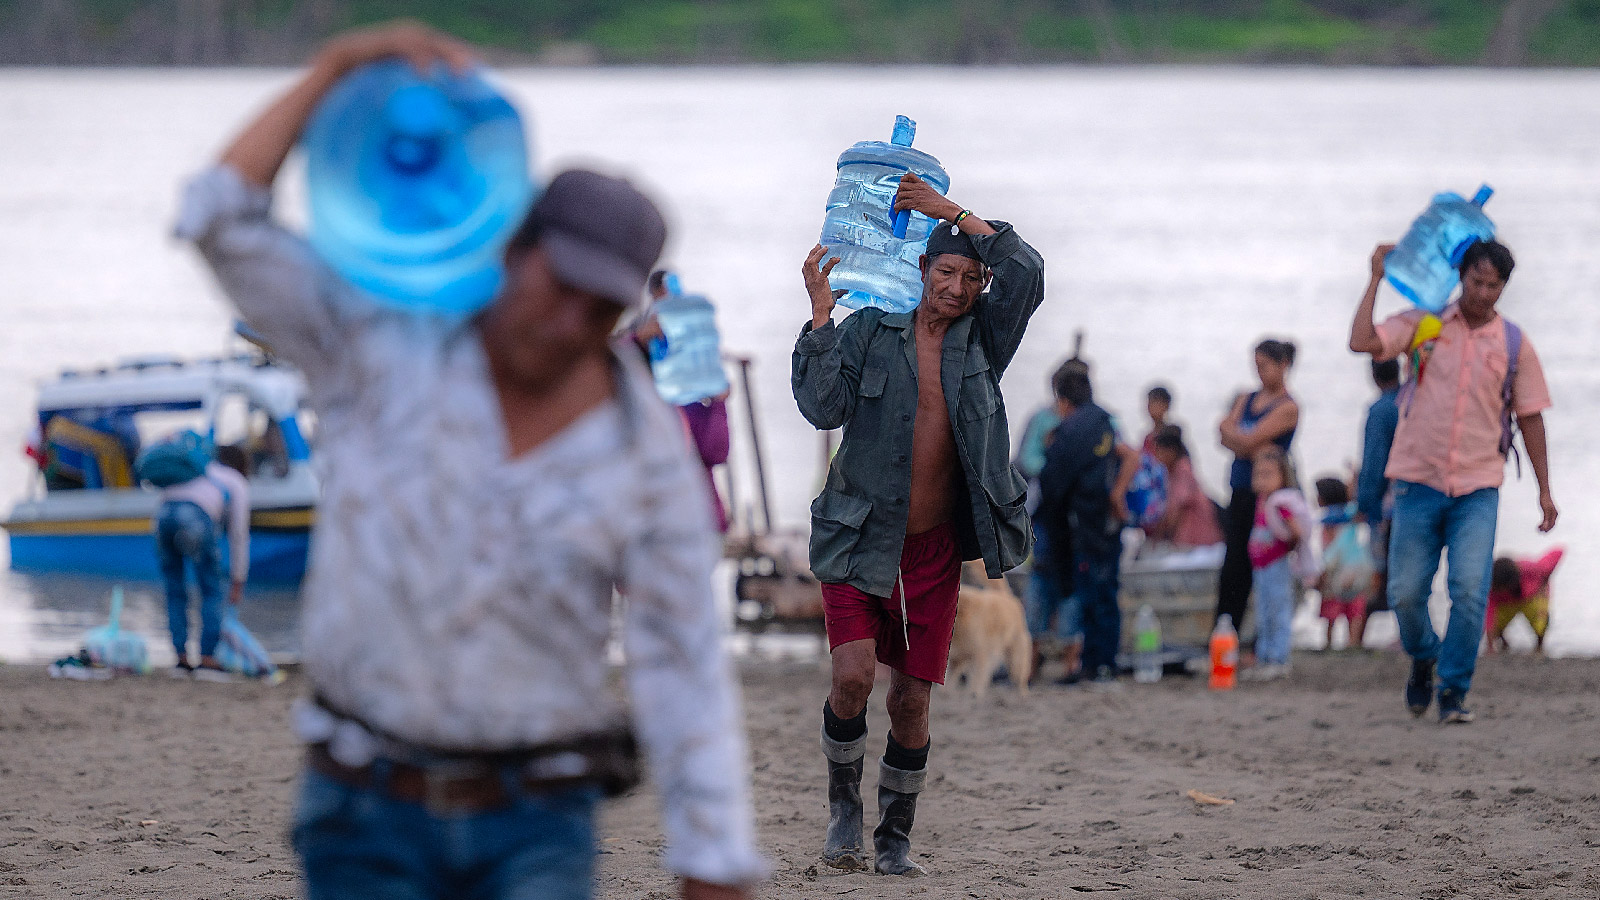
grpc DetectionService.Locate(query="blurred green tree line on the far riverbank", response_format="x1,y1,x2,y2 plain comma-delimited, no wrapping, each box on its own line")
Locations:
0,0,1600,66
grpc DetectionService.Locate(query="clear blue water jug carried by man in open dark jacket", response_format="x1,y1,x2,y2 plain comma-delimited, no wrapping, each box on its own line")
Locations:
822,115,950,312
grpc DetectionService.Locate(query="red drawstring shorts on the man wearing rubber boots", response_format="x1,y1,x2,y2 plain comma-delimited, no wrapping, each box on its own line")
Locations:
822,522,962,684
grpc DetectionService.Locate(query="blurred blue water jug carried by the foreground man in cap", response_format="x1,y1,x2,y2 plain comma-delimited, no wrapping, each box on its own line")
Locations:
301,61,536,312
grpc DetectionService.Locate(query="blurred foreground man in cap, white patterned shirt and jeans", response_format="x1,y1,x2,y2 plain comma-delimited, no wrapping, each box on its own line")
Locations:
178,19,765,900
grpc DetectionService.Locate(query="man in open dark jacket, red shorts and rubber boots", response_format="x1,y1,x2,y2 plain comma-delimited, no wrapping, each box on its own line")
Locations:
792,175,1045,874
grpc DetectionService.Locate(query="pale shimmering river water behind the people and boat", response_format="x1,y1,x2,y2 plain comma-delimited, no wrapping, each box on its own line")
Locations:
0,67,1600,660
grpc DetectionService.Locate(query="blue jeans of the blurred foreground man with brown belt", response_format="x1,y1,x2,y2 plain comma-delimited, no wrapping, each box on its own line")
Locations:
291,764,600,900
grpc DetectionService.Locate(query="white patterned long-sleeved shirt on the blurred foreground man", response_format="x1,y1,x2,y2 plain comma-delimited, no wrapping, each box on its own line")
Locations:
178,167,763,884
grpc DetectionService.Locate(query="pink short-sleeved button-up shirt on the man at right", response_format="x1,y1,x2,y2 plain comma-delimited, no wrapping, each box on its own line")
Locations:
1378,304,1550,496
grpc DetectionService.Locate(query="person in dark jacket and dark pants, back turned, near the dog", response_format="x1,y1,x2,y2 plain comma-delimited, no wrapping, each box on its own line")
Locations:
1035,365,1139,684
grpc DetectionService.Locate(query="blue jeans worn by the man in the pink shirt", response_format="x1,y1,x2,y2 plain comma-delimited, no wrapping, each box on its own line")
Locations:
1389,482,1499,693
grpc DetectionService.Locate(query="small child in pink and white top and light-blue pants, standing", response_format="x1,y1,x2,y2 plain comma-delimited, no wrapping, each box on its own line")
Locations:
1248,444,1315,681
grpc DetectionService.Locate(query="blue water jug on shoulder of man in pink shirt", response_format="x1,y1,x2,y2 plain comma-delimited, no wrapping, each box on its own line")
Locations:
1384,184,1494,315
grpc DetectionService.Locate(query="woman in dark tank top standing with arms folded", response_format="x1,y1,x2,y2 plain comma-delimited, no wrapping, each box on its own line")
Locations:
1216,338,1299,629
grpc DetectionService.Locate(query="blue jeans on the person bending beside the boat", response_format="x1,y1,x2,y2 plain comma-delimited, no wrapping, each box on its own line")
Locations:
155,500,222,657
